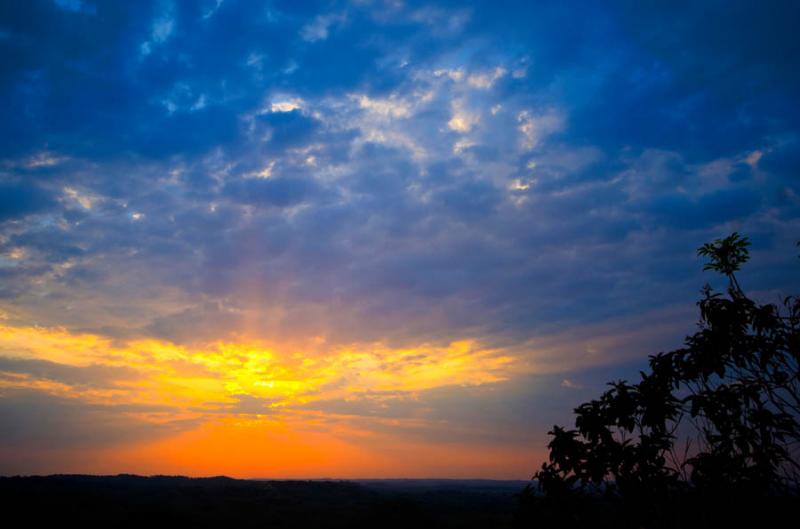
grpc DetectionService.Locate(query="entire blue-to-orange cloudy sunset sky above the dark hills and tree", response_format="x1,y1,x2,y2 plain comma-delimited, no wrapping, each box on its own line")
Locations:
0,0,800,479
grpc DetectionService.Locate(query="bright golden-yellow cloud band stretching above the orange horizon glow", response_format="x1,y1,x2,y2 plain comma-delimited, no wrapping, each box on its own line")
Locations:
0,325,514,408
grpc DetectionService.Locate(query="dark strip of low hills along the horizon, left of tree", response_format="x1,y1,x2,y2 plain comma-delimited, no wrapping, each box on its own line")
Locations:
0,475,525,529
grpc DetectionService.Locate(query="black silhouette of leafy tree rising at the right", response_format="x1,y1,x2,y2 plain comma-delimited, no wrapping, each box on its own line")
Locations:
523,233,800,526
